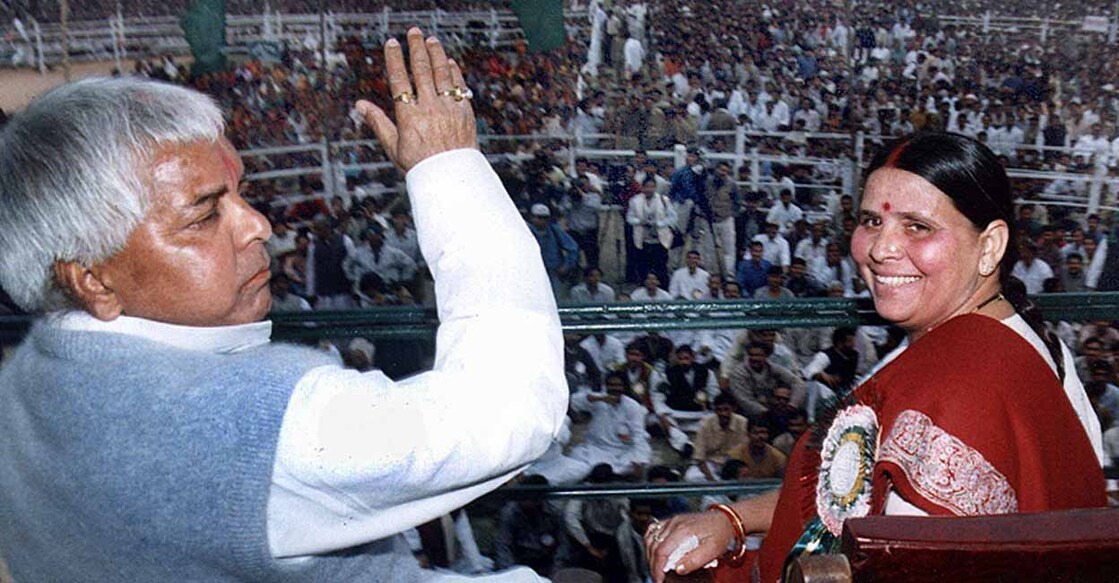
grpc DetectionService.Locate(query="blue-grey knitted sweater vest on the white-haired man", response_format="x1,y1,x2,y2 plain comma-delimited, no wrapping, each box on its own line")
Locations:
0,323,422,583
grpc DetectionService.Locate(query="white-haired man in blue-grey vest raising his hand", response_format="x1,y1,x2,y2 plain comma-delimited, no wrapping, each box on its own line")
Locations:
0,29,567,582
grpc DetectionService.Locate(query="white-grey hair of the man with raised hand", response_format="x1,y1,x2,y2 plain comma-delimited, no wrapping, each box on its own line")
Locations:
0,77,225,311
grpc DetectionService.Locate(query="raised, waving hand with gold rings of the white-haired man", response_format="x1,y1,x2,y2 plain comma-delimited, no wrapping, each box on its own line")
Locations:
355,27,478,172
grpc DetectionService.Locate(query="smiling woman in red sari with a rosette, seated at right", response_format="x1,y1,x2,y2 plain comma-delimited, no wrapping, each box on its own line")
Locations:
647,133,1106,582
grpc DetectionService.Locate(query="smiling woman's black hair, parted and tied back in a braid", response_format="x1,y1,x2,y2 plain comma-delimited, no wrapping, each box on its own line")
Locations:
866,132,1064,380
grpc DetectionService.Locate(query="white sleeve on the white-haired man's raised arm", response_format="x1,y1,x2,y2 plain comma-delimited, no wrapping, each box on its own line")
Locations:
267,150,567,557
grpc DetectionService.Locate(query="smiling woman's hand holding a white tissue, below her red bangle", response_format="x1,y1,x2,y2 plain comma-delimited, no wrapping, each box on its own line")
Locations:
645,511,734,583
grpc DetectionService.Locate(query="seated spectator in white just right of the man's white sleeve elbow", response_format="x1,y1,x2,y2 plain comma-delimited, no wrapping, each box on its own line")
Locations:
568,373,652,477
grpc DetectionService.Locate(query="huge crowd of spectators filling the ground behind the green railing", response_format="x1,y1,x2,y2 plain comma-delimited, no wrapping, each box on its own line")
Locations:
6,0,1119,581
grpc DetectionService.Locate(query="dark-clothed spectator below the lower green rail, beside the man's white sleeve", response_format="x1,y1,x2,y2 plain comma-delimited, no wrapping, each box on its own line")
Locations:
493,476,570,577
